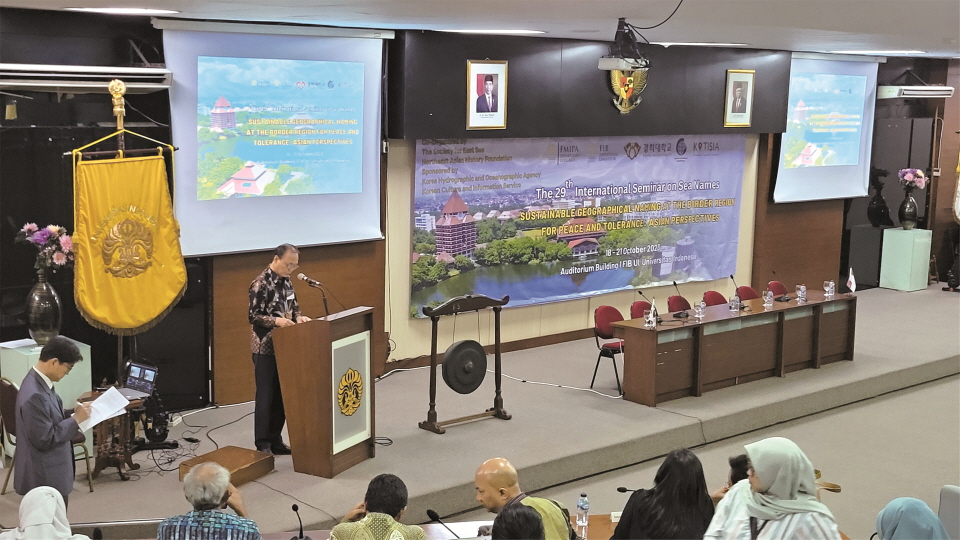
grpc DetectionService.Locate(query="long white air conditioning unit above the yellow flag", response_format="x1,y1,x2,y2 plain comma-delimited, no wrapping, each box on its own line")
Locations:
0,64,173,94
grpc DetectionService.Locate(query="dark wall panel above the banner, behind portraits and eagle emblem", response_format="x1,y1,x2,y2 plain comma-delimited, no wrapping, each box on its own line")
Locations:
388,32,790,139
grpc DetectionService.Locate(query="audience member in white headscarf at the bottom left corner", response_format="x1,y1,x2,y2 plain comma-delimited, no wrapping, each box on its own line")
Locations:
0,486,90,540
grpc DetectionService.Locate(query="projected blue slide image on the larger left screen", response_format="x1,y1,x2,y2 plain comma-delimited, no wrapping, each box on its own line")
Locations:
196,56,364,201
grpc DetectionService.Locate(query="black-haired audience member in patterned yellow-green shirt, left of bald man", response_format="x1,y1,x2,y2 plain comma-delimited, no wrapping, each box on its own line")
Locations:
330,474,426,540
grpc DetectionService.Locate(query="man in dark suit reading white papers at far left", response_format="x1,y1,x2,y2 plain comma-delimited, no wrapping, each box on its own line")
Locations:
13,336,90,503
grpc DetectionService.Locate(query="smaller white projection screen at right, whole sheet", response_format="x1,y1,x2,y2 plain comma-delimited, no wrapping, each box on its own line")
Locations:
773,57,877,203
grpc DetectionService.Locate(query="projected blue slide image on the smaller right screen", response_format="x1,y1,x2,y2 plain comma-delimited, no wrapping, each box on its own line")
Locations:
781,73,867,169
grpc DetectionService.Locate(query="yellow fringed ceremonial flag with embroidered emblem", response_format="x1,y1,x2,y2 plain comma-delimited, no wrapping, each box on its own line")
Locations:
73,156,187,336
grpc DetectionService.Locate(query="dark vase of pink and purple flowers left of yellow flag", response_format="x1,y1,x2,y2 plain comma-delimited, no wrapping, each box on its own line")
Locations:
16,223,75,346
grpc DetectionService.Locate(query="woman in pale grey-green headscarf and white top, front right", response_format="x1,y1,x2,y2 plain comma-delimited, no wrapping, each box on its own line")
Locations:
703,437,840,540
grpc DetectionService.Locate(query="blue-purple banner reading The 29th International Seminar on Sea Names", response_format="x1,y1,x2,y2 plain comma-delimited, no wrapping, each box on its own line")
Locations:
410,135,746,317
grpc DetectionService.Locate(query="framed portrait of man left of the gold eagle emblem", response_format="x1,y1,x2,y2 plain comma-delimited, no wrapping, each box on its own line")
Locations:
467,60,507,129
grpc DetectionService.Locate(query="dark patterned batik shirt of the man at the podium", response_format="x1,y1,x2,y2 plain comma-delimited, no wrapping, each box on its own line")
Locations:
248,266,300,354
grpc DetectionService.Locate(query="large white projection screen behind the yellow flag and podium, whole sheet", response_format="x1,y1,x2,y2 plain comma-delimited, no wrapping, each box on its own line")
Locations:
163,29,383,256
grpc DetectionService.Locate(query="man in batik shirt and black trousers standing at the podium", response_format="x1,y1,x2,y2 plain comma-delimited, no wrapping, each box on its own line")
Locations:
248,244,310,455
